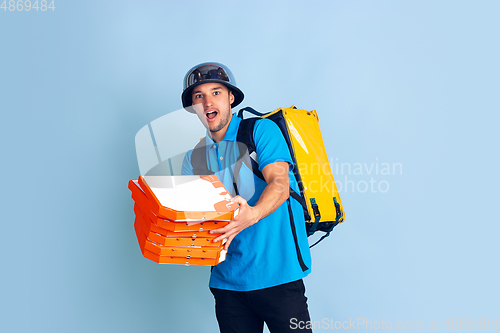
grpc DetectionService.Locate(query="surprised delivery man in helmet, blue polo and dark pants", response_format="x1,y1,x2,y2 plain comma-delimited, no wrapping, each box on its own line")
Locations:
182,63,311,333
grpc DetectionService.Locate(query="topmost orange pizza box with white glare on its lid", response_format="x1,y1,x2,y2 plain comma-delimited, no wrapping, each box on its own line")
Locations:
138,175,239,221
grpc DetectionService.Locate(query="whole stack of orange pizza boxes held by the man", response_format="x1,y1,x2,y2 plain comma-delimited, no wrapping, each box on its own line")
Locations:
128,175,239,265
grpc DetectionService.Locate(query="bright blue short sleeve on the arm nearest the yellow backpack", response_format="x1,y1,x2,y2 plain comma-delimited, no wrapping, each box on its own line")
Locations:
253,119,293,171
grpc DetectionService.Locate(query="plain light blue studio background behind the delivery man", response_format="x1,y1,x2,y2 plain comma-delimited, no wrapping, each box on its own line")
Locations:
0,0,500,332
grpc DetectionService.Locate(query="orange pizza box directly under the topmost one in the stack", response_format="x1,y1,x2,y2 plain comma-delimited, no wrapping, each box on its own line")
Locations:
132,198,229,232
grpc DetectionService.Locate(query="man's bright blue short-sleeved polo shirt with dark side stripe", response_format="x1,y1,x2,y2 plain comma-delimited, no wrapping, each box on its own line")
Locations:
182,114,311,291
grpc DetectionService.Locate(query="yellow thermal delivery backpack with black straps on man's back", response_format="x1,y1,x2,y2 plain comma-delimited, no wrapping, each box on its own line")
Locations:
235,105,345,247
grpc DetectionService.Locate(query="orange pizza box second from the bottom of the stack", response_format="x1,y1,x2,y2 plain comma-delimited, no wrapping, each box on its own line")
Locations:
134,224,223,259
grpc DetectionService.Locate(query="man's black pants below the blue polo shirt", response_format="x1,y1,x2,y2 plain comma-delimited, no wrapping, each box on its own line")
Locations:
210,280,312,333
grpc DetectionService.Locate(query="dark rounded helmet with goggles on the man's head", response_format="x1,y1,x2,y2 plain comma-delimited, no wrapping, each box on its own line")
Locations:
181,62,245,113
